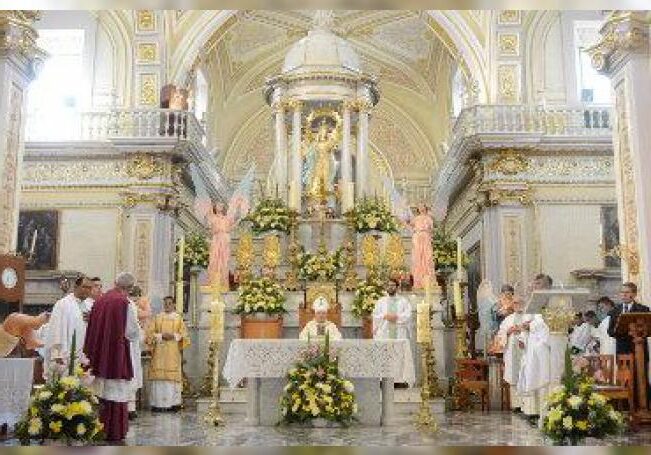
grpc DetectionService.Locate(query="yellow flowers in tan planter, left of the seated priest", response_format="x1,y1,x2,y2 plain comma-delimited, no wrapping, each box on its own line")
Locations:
234,276,287,338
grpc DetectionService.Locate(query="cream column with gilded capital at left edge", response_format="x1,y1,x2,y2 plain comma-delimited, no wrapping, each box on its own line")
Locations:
0,10,45,254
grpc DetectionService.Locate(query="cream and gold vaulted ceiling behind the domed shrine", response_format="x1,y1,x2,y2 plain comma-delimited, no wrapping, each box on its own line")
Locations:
194,10,468,187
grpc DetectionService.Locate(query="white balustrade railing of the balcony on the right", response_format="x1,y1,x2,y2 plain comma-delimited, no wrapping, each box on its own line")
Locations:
450,105,612,145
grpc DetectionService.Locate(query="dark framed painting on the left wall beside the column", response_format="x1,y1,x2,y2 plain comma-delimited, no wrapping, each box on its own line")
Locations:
16,210,59,270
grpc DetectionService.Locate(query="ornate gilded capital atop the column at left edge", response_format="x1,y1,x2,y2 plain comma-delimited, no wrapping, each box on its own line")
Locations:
0,10,47,81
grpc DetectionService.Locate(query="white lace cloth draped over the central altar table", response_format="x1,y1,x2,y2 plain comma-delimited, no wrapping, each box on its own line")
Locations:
222,339,415,387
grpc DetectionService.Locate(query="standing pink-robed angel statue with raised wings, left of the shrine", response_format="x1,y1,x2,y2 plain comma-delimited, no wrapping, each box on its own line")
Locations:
193,165,255,290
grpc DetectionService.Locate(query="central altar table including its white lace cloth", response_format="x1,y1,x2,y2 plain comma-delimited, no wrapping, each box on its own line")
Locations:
222,339,415,425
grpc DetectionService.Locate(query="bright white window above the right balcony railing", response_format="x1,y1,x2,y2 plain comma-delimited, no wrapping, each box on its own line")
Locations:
574,21,611,104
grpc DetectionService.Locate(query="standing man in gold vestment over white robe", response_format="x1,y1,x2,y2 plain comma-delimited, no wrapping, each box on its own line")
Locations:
145,297,190,411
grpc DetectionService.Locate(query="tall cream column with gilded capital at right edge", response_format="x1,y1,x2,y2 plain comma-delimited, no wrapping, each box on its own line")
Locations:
591,11,651,302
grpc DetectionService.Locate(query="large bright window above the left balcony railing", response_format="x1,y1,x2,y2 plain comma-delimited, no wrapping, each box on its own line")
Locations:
25,29,88,141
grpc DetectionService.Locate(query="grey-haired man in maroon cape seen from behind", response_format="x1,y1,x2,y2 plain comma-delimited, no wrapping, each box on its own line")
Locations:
84,273,139,442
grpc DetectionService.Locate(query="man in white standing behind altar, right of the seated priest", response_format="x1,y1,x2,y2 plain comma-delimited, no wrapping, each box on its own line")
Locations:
373,280,411,340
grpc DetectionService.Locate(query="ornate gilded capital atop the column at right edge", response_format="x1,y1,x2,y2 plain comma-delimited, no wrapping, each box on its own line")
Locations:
588,11,649,75
